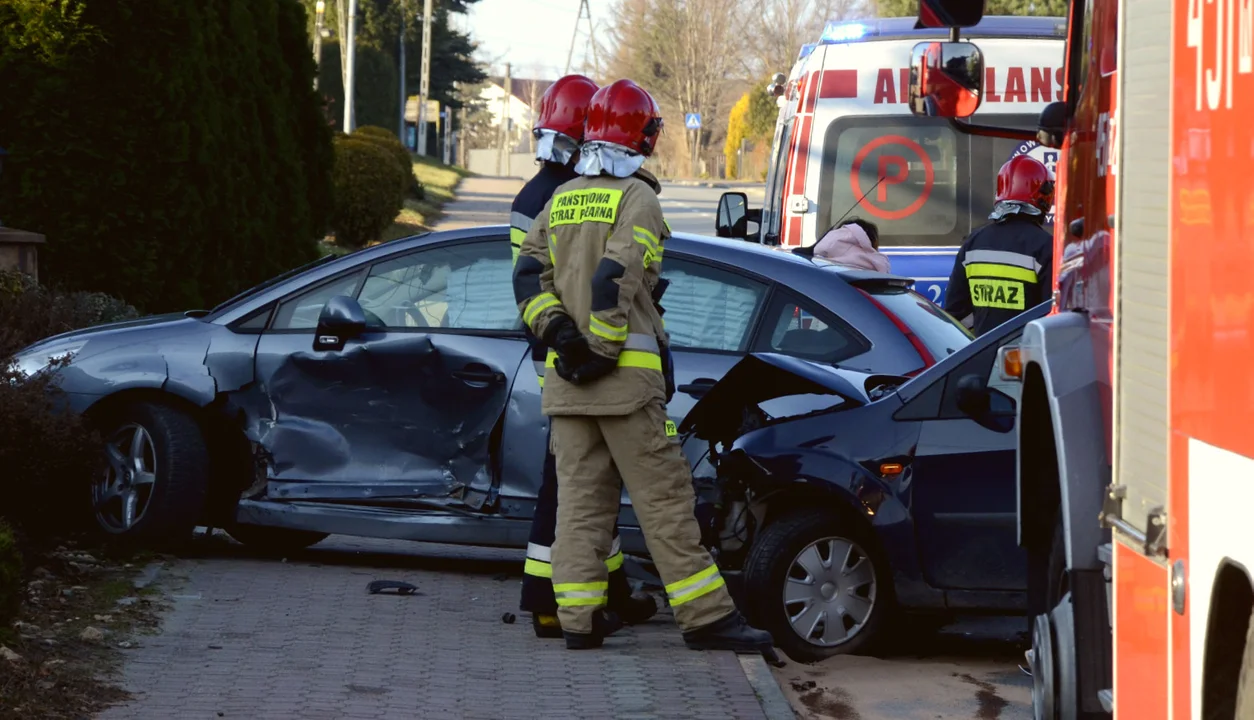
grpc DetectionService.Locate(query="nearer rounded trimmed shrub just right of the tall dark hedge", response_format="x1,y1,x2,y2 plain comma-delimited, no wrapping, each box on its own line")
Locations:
331,137,404,248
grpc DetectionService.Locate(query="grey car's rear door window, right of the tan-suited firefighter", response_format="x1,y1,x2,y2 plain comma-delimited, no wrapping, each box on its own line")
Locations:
662,257,766,352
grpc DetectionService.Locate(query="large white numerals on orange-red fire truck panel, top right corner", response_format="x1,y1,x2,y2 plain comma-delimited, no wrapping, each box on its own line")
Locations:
1185,0,1254,110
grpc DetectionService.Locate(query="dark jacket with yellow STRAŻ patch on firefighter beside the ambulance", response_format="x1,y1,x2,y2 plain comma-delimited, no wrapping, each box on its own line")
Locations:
944,213,1053,336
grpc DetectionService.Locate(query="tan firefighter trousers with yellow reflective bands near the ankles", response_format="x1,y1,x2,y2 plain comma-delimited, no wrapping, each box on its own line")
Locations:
551,400,736,633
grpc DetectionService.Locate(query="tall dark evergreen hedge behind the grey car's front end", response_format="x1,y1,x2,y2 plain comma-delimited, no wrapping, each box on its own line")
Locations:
0,0,332,312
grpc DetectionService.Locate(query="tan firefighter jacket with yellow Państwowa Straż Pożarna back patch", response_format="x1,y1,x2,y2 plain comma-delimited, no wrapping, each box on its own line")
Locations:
514,171,670,415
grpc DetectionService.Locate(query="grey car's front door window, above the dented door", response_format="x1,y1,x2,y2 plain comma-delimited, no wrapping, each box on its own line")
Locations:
357,242,522,330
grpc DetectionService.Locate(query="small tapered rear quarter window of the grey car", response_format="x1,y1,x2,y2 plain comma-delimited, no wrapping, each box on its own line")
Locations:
759,294,869,363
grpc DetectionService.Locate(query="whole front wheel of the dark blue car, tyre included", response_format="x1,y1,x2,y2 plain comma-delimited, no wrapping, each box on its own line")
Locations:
744,508,894,662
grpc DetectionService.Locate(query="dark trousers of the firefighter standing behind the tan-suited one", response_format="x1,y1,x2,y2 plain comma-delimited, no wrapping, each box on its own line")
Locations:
519,433,631,615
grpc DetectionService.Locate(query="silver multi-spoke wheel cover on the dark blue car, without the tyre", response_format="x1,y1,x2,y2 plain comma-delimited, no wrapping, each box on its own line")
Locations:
784,537,877,647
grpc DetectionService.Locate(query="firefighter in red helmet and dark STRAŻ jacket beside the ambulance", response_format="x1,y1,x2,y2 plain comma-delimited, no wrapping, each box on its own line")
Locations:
944,156,1053,336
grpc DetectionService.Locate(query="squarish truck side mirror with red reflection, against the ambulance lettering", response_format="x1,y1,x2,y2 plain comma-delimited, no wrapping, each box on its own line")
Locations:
909,40,984,118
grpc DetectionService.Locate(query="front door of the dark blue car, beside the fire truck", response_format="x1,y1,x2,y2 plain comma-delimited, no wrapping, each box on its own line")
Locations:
912,329,1027,591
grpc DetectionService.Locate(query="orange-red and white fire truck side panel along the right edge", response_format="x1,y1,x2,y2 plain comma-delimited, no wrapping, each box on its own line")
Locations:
1167,0,1254,717
